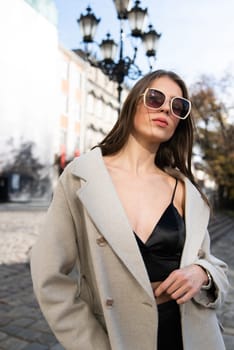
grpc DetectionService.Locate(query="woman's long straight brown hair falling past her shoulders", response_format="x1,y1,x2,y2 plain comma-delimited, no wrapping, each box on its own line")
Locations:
97,70,207,202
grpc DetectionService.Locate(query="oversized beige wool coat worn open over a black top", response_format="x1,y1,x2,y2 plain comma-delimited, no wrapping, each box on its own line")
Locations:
31,148,228,350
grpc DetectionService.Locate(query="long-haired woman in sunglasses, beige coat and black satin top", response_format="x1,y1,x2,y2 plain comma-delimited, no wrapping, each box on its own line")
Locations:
31,70,228,350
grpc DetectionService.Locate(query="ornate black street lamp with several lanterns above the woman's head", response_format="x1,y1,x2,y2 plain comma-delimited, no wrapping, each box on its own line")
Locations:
77,0,161,109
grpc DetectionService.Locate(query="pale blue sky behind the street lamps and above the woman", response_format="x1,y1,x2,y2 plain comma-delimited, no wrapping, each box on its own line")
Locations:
55,0,234,84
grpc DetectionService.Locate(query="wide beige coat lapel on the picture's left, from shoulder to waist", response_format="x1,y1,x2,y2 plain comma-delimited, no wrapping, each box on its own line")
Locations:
73,148,154,298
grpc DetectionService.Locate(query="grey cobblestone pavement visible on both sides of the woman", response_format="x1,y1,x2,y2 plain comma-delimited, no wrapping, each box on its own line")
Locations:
0,209,234,350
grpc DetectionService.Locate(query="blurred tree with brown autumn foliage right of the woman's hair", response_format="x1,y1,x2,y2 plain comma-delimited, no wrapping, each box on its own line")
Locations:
191,76,234,208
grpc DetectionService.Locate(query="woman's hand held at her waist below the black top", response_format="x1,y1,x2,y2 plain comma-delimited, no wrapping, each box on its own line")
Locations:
154,264,208,304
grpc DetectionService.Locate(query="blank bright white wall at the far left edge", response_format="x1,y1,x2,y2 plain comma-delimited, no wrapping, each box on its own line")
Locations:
0,0,59,170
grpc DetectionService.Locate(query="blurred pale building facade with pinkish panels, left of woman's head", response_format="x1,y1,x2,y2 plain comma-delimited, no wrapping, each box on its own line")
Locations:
58,46,123,161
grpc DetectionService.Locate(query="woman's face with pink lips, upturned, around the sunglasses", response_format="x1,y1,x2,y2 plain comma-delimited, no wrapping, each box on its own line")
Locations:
131,76,183,145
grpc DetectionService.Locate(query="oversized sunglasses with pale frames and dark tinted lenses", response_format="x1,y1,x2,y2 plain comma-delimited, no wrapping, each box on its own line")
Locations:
142,88,191,119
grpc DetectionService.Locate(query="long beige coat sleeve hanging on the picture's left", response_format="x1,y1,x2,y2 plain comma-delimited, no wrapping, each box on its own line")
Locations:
31,176,111,350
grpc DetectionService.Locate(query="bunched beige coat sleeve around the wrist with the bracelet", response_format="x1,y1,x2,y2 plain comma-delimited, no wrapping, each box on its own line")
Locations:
194,231,229,308
